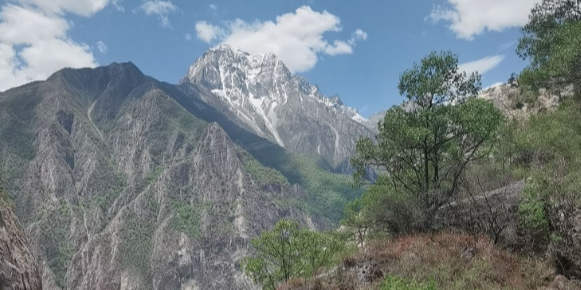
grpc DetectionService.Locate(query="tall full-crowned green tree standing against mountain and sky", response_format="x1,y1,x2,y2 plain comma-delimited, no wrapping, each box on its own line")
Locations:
352,52,503,229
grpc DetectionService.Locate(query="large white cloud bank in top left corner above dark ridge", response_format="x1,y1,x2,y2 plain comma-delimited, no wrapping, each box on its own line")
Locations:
0,0,103,91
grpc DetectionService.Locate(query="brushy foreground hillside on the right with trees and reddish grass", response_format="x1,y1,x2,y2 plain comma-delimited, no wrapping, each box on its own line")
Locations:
245,0,581,290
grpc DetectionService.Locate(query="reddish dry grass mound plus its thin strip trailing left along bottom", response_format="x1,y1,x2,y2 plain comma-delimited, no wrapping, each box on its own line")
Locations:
280,232,553,290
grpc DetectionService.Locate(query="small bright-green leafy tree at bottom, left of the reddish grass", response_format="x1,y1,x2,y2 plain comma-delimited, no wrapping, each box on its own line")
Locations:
242,220,346,290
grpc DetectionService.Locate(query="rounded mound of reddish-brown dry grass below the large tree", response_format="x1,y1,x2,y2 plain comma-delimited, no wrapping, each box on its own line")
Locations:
366,232,546,290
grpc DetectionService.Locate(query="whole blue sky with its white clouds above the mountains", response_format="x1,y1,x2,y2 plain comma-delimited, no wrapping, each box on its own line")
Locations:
0,0,535,116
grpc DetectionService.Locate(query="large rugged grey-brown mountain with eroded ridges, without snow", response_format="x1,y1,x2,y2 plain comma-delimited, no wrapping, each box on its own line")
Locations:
0,63,334,289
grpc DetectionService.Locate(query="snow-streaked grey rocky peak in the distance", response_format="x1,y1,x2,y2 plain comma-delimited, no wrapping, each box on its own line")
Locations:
181,45,371,169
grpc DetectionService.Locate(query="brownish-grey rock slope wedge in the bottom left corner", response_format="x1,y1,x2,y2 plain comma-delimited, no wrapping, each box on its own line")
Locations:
0,196,42,290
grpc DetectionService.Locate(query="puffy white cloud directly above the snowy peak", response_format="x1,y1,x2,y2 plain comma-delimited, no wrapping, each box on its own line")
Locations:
196,6,367,72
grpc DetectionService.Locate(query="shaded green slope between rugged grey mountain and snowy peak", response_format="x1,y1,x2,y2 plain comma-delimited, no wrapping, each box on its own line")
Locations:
160,83,362,224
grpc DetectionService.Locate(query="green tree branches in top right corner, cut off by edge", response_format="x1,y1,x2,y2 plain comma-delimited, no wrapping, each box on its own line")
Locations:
517,0,581,94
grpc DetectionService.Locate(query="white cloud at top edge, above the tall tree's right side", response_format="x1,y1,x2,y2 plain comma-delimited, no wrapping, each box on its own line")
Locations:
428,0,539,40
